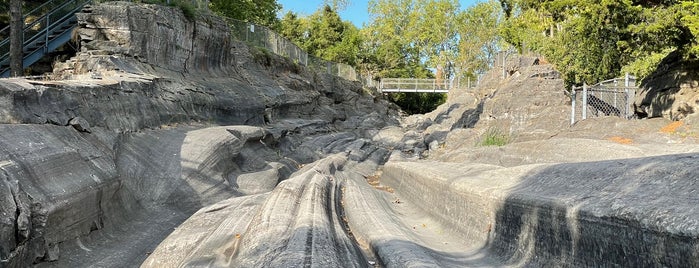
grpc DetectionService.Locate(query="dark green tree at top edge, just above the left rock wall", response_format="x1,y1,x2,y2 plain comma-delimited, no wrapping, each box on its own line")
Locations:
209,0,281,28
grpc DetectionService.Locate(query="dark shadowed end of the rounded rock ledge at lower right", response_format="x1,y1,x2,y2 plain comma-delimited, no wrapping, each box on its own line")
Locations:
488,154,699,267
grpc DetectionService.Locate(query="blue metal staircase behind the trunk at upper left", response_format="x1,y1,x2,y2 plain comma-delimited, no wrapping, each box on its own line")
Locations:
0,0,91,77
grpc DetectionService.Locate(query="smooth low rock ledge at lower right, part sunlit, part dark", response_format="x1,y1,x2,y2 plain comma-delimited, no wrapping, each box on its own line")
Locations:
382,153,699,267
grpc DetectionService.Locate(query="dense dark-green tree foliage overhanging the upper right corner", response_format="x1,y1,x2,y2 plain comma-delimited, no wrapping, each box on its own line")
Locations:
500,0,699,84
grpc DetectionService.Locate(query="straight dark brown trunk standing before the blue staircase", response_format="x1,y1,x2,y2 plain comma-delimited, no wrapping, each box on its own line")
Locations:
10,0,24,76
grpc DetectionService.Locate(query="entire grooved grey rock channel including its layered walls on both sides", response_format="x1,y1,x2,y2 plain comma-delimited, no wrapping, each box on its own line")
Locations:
0,2,699,267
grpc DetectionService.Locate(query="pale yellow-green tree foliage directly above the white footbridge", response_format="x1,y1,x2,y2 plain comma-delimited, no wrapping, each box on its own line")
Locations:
362,0,459,78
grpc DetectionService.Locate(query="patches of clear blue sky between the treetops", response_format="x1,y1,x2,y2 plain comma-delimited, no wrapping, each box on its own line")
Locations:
277,0,479,28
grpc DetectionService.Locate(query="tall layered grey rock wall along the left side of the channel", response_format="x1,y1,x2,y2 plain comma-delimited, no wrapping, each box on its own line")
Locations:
0,2,397,267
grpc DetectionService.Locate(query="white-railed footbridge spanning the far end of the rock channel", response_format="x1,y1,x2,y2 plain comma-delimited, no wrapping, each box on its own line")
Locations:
378,78,451,93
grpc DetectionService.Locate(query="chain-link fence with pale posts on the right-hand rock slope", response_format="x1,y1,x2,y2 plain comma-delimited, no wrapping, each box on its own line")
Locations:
570,74,638,125
